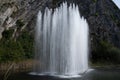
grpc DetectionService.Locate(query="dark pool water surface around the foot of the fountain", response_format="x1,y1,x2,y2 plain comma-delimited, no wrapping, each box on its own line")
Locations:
0,69,120,80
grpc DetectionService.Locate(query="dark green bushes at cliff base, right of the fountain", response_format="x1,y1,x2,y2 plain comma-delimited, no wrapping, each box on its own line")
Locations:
92,41,120,64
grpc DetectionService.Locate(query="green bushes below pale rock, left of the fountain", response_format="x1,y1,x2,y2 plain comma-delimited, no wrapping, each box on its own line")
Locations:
0,31,33,62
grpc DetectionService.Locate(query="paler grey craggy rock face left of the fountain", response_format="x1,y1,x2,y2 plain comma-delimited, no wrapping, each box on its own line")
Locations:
0,0,46,38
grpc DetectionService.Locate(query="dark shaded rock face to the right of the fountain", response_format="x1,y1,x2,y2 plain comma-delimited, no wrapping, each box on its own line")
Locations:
86,0,120,48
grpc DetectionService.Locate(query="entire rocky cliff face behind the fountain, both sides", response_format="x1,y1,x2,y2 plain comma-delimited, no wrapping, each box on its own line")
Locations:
0,0,120,53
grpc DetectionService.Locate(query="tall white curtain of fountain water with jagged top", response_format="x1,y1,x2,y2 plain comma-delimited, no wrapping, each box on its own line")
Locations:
31,3,88,76
